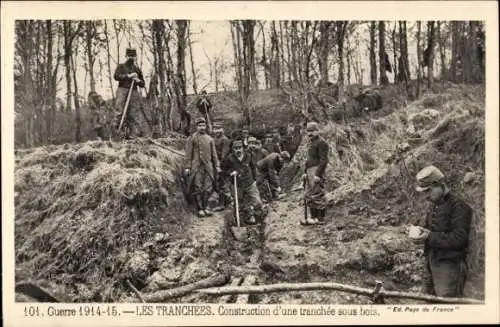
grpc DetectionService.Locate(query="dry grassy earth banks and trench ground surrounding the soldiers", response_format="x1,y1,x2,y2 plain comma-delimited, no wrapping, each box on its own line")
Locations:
15,85,485,303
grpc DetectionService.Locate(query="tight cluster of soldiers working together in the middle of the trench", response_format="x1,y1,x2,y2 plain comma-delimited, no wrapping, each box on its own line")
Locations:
184,116,296,224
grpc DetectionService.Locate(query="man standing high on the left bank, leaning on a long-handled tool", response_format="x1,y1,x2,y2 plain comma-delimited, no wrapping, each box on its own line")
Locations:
114,49,145,138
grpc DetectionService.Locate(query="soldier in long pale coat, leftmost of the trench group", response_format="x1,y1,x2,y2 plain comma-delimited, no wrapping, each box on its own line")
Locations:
184,117,221,217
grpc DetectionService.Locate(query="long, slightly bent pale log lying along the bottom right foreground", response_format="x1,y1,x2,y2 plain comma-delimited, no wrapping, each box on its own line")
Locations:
197,283,484,304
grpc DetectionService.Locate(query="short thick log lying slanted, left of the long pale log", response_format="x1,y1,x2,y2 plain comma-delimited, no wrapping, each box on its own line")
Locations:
142,274,229,302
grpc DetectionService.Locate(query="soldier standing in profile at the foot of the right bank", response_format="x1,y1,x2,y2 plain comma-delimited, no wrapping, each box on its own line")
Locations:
301,122,329,225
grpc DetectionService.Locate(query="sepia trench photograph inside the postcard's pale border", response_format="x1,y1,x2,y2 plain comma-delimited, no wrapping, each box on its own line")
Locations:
2,1,498,326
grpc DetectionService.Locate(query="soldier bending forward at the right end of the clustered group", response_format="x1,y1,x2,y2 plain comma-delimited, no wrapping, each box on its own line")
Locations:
257,151,290,200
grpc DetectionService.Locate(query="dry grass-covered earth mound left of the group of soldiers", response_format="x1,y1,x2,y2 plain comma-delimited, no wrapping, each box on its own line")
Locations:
15,138,193,300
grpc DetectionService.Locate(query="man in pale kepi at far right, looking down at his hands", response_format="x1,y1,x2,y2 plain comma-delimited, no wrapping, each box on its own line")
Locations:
409,166,473,297
